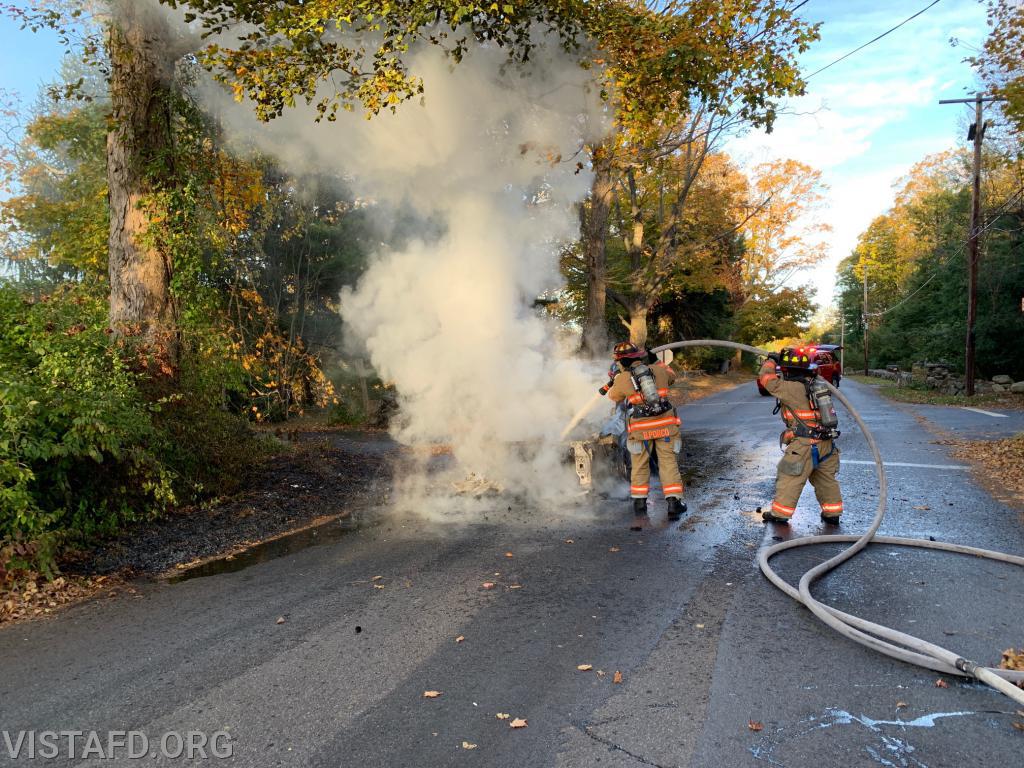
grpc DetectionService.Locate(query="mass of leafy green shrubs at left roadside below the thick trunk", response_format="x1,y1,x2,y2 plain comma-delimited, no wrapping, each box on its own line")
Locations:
0,283,284,572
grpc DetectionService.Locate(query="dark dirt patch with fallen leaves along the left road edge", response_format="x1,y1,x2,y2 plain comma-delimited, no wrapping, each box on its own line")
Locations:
0,425,400,625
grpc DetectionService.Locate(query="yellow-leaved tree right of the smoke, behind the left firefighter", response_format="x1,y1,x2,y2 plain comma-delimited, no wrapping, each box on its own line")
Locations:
584,0,817,351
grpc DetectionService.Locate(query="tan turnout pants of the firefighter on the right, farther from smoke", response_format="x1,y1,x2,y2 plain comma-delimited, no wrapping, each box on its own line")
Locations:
771,439,843,517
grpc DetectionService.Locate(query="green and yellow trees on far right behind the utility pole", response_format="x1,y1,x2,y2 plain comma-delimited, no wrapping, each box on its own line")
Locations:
838,146,1024,378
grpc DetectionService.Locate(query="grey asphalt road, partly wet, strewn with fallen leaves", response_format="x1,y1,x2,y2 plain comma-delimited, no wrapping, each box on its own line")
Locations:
0,383,1024,768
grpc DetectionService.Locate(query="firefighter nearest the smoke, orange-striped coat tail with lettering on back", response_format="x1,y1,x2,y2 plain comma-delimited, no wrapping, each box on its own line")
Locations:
600,341,686,529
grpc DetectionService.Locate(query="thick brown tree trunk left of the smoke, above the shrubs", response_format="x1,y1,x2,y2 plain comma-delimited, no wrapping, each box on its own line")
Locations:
106,0,177,367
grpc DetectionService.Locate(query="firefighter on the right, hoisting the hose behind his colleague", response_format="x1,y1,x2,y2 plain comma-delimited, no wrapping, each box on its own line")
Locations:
758,347,843,525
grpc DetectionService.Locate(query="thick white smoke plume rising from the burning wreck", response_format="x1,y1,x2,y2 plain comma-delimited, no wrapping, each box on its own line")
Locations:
197,33,605,506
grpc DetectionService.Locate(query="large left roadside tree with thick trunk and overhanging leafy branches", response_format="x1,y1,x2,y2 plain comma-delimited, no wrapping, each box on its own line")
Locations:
7,0,589,364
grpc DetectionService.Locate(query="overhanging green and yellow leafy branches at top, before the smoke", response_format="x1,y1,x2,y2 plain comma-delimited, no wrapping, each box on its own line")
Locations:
172,0,596,120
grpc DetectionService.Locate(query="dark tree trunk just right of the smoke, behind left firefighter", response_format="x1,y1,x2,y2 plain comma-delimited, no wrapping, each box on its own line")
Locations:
581,145,612,357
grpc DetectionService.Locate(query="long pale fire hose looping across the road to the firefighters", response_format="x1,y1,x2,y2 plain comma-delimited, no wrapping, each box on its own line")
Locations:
638,339,1024,705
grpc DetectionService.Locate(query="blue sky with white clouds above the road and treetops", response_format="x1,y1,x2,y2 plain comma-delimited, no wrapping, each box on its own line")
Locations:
0,0,987,305
